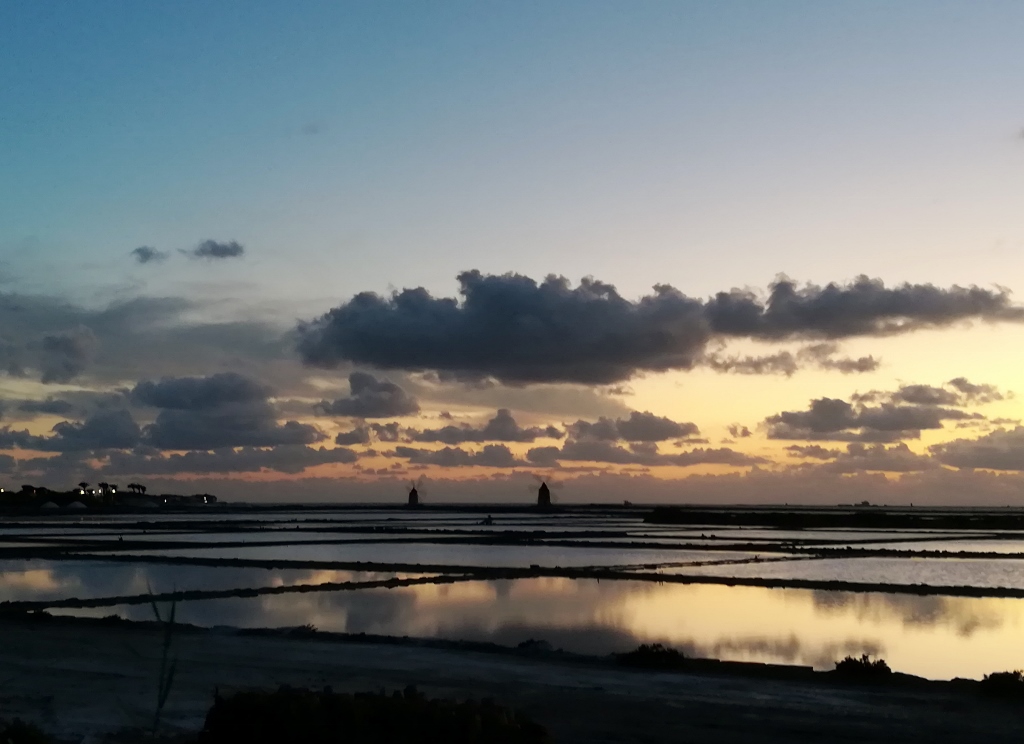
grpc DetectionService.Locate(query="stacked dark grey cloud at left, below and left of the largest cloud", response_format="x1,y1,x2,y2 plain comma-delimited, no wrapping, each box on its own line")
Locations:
131,373,324,450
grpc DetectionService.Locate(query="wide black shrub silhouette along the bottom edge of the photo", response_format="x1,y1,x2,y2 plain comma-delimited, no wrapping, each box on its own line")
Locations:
199,687,550,744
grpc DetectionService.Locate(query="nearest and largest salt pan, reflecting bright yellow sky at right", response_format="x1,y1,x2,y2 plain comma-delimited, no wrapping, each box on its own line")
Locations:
56,578,1024,679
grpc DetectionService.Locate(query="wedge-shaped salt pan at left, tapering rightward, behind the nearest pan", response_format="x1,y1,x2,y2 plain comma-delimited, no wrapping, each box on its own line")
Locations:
0,560,422,602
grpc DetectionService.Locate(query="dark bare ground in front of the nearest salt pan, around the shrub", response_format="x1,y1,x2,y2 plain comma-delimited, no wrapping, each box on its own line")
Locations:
0,620,1024,744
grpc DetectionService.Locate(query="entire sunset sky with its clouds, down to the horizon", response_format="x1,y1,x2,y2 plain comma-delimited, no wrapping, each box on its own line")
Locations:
0,0,1024,506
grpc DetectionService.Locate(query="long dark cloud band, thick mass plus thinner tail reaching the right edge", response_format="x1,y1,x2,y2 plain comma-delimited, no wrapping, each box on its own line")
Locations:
298,271,1024,384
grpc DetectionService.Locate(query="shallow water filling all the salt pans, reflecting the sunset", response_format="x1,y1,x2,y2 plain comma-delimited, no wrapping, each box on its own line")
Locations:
14,508,1024,677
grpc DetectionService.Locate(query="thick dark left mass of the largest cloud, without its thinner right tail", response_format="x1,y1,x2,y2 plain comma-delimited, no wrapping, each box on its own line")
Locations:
299,271,708,384
